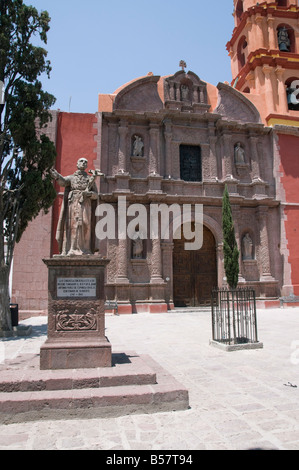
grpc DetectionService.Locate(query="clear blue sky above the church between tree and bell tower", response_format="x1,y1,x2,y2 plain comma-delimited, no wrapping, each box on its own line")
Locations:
24,0,234,113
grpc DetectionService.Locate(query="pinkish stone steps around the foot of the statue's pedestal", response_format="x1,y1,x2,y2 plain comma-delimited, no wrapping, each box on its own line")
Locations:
0,354,189,423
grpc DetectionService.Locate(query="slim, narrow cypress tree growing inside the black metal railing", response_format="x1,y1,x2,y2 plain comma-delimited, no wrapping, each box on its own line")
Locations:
222,185,239,289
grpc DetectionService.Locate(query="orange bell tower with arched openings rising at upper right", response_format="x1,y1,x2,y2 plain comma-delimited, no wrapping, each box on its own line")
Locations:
227,0,299,127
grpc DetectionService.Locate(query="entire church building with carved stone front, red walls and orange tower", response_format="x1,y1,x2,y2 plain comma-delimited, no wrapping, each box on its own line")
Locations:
12,0,299,313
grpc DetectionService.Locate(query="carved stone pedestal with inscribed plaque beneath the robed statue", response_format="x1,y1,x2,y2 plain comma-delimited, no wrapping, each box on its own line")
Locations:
40,255,112,370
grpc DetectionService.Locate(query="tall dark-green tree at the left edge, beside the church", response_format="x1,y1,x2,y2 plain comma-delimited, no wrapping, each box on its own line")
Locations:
0,0,56,330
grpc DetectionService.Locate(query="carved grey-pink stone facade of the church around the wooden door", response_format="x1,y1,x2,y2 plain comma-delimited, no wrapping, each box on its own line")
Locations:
10,70,283,314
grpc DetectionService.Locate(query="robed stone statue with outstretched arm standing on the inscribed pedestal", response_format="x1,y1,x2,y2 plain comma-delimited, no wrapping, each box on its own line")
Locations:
51,158,103,256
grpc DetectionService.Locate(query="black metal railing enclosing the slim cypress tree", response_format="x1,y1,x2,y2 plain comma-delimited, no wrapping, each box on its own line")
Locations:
211,288,258,344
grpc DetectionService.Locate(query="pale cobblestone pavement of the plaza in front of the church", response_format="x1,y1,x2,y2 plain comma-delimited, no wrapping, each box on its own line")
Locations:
0,308,299,450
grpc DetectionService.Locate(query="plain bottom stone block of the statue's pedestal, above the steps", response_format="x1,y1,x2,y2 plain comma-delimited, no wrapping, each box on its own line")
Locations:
40,338,112,370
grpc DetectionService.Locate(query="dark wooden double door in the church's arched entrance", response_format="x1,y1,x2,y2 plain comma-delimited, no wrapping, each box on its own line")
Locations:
173,226,217,307
